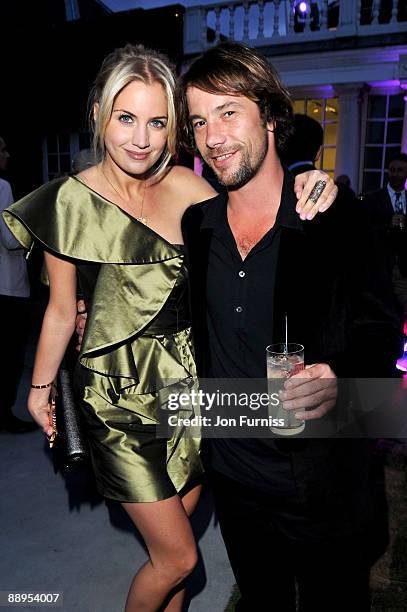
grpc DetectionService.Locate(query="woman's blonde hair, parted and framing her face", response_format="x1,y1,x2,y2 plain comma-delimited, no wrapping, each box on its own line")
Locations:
89,44,176,179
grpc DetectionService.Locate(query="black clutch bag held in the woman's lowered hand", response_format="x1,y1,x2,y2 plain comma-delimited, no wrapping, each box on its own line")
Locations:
52,365,89,472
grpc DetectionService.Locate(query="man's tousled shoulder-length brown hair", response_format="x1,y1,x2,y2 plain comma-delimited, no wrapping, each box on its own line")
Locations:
176,42,293,154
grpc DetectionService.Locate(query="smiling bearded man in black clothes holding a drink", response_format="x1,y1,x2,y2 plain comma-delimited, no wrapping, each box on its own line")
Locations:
178,42,400,612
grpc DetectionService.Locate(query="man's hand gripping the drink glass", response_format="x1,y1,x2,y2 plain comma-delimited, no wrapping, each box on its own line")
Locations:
280,363,338,421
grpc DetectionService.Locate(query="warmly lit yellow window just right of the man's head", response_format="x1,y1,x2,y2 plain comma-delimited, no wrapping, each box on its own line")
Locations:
294,98,339,178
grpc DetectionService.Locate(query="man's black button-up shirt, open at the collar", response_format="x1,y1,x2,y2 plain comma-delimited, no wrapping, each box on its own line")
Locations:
207,173,302,495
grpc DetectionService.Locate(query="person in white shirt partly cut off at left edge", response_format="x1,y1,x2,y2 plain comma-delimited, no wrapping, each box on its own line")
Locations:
0,137,37,433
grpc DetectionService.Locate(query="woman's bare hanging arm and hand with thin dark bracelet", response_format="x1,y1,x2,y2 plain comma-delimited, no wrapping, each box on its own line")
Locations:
28,253,76,436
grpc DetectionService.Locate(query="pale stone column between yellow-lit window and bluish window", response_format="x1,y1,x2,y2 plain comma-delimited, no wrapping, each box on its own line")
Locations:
335,83,363,192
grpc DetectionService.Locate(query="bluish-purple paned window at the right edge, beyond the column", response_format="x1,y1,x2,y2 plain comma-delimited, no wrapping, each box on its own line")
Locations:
362,94,404,193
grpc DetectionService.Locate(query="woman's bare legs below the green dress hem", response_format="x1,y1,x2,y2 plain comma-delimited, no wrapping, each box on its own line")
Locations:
123,487,200,612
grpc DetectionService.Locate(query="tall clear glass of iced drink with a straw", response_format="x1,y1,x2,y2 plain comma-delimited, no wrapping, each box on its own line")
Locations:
266,342,305,436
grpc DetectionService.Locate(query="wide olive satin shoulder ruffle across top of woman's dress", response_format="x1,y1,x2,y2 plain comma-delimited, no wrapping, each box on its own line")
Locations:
3,177,179,264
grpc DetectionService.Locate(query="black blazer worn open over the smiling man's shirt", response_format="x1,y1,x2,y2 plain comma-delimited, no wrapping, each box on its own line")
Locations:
182,173,401,559
